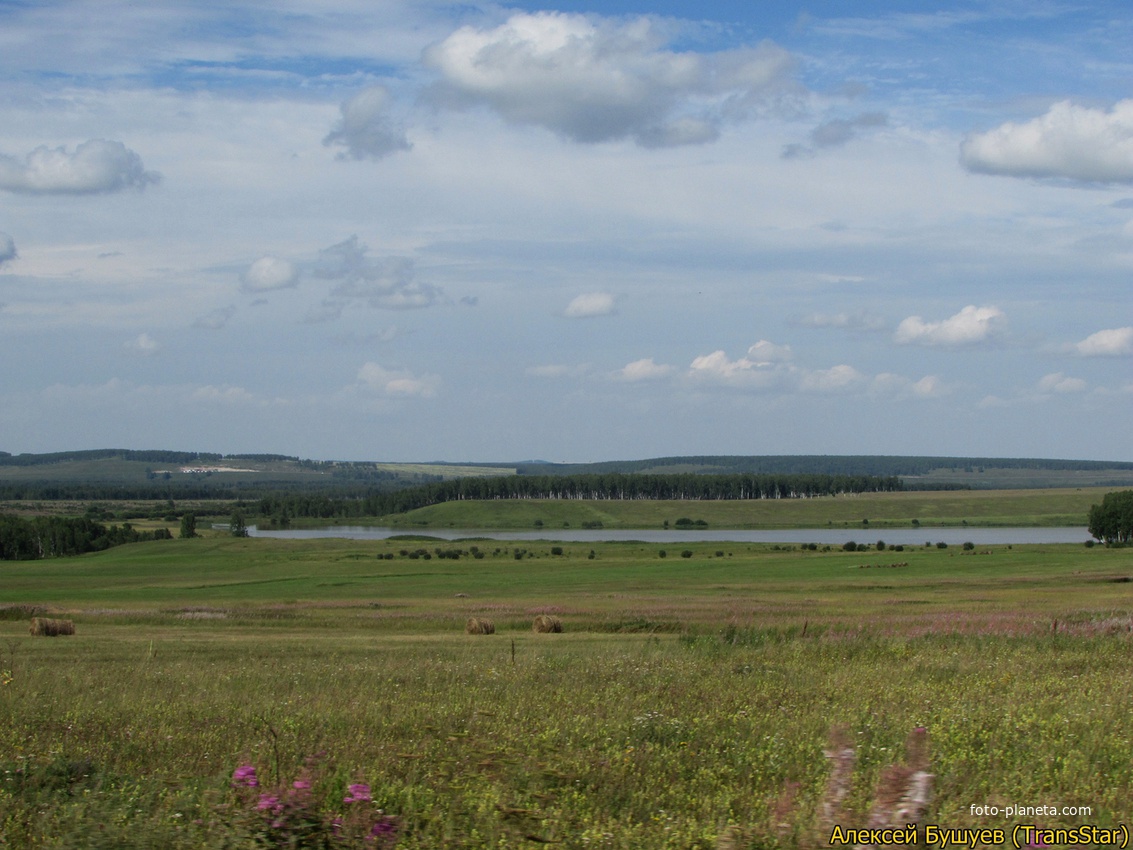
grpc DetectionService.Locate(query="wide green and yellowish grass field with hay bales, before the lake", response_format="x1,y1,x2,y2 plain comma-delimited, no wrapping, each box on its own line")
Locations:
0,537,1133,850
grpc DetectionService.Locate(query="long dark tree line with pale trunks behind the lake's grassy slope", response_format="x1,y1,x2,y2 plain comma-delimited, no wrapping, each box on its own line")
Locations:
258,473,903,519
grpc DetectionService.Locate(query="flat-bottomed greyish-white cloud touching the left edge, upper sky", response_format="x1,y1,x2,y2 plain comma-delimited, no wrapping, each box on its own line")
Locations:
0,138,161,195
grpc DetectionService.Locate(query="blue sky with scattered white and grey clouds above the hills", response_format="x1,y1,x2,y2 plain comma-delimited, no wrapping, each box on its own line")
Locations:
0,0,1133,462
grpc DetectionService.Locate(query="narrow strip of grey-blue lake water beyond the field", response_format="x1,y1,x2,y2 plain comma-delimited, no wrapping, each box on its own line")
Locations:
248,526,1090,546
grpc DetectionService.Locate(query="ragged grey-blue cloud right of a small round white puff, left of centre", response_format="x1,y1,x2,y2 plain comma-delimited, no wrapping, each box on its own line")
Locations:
314,236,441,313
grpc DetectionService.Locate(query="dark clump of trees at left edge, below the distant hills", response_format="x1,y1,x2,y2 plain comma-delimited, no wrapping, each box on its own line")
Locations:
0,513,172,561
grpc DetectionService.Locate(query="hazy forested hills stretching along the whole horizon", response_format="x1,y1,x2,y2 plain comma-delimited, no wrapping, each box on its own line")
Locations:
0,449,1133,500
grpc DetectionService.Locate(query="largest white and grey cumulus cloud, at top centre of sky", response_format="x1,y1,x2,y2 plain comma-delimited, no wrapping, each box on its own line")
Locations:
424,11,792,147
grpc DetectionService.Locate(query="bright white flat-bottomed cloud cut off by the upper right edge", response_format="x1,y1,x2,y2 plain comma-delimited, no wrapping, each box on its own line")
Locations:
960,100,1133,182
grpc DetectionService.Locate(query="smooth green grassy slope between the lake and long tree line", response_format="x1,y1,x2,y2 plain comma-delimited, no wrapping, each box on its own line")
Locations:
380,487,1109,528
